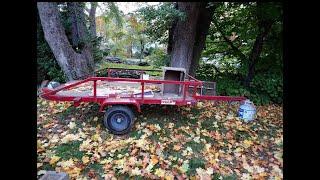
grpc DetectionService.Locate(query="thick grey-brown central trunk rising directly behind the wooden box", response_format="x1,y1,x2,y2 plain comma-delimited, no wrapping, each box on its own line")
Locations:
170,2,200,73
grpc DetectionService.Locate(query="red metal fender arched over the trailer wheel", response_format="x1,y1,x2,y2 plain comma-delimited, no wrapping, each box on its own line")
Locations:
99,98,141,113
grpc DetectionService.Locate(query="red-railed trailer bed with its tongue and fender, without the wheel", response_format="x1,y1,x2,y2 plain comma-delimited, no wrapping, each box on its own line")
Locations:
40,70,246,112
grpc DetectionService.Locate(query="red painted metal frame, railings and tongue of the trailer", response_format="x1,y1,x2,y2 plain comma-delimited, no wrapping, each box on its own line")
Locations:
40,69,246,112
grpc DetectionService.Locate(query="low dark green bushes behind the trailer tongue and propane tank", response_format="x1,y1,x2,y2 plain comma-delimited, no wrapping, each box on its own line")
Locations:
196,64,283,105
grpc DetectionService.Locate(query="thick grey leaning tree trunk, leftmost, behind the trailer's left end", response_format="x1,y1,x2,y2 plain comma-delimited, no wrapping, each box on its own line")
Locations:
37,2,92,80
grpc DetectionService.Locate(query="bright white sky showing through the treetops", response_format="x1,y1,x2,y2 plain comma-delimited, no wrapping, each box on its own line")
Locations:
96,2,160,16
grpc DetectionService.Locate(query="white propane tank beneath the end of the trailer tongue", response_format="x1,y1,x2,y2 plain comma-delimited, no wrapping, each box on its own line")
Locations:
238,99,256,122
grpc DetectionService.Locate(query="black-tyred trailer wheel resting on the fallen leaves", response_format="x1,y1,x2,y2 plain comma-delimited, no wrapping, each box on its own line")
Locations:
103,106,134,135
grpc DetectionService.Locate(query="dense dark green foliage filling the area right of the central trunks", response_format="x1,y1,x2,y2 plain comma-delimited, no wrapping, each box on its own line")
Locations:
196,2,283,104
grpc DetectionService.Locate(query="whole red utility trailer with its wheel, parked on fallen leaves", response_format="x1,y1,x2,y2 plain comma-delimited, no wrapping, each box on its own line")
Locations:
40,69,246,134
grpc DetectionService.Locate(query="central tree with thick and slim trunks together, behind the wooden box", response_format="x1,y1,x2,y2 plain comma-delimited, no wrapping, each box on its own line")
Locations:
168,2,215,75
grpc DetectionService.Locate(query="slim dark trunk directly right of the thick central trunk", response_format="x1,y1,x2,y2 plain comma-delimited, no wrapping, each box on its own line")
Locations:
189,3,216,76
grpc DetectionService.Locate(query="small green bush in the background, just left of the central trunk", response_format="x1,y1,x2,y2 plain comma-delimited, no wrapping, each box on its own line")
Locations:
145,49,170,67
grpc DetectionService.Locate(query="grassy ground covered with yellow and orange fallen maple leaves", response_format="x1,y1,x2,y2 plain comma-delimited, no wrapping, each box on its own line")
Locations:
37,99,283,179
